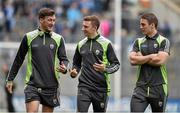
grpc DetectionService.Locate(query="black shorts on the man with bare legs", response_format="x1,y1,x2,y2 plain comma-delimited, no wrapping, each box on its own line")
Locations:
24,85,60,107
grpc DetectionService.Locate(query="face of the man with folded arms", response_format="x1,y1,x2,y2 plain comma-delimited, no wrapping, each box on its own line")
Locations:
140,19,153,35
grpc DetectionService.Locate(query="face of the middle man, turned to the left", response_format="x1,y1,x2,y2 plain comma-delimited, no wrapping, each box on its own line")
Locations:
82,21,96,37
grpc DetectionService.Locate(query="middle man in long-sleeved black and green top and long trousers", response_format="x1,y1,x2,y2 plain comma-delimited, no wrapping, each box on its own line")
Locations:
70,15,120,112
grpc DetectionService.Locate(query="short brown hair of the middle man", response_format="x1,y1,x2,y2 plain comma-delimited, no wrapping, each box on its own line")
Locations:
83,15,100,30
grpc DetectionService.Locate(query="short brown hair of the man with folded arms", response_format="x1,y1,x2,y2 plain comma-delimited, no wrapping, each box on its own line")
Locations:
141,13,158,29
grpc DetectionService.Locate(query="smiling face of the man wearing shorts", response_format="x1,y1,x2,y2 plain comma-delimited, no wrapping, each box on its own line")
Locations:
40,15,56,32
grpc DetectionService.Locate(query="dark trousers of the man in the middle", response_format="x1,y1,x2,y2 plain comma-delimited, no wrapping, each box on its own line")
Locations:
77,88,109,112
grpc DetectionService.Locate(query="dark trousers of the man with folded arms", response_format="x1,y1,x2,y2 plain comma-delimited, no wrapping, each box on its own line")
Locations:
130,85,168,112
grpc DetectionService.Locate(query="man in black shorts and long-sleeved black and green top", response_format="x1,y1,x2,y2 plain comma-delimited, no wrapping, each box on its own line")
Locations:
6,8,68,113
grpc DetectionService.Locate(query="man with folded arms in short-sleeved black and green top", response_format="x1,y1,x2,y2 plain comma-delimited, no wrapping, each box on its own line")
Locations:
129,13,170,112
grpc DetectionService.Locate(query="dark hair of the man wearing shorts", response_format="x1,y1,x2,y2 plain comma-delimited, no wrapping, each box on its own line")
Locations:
38,7,55,19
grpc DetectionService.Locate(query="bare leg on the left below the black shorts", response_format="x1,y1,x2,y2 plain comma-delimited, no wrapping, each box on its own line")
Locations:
26,101,39,113
